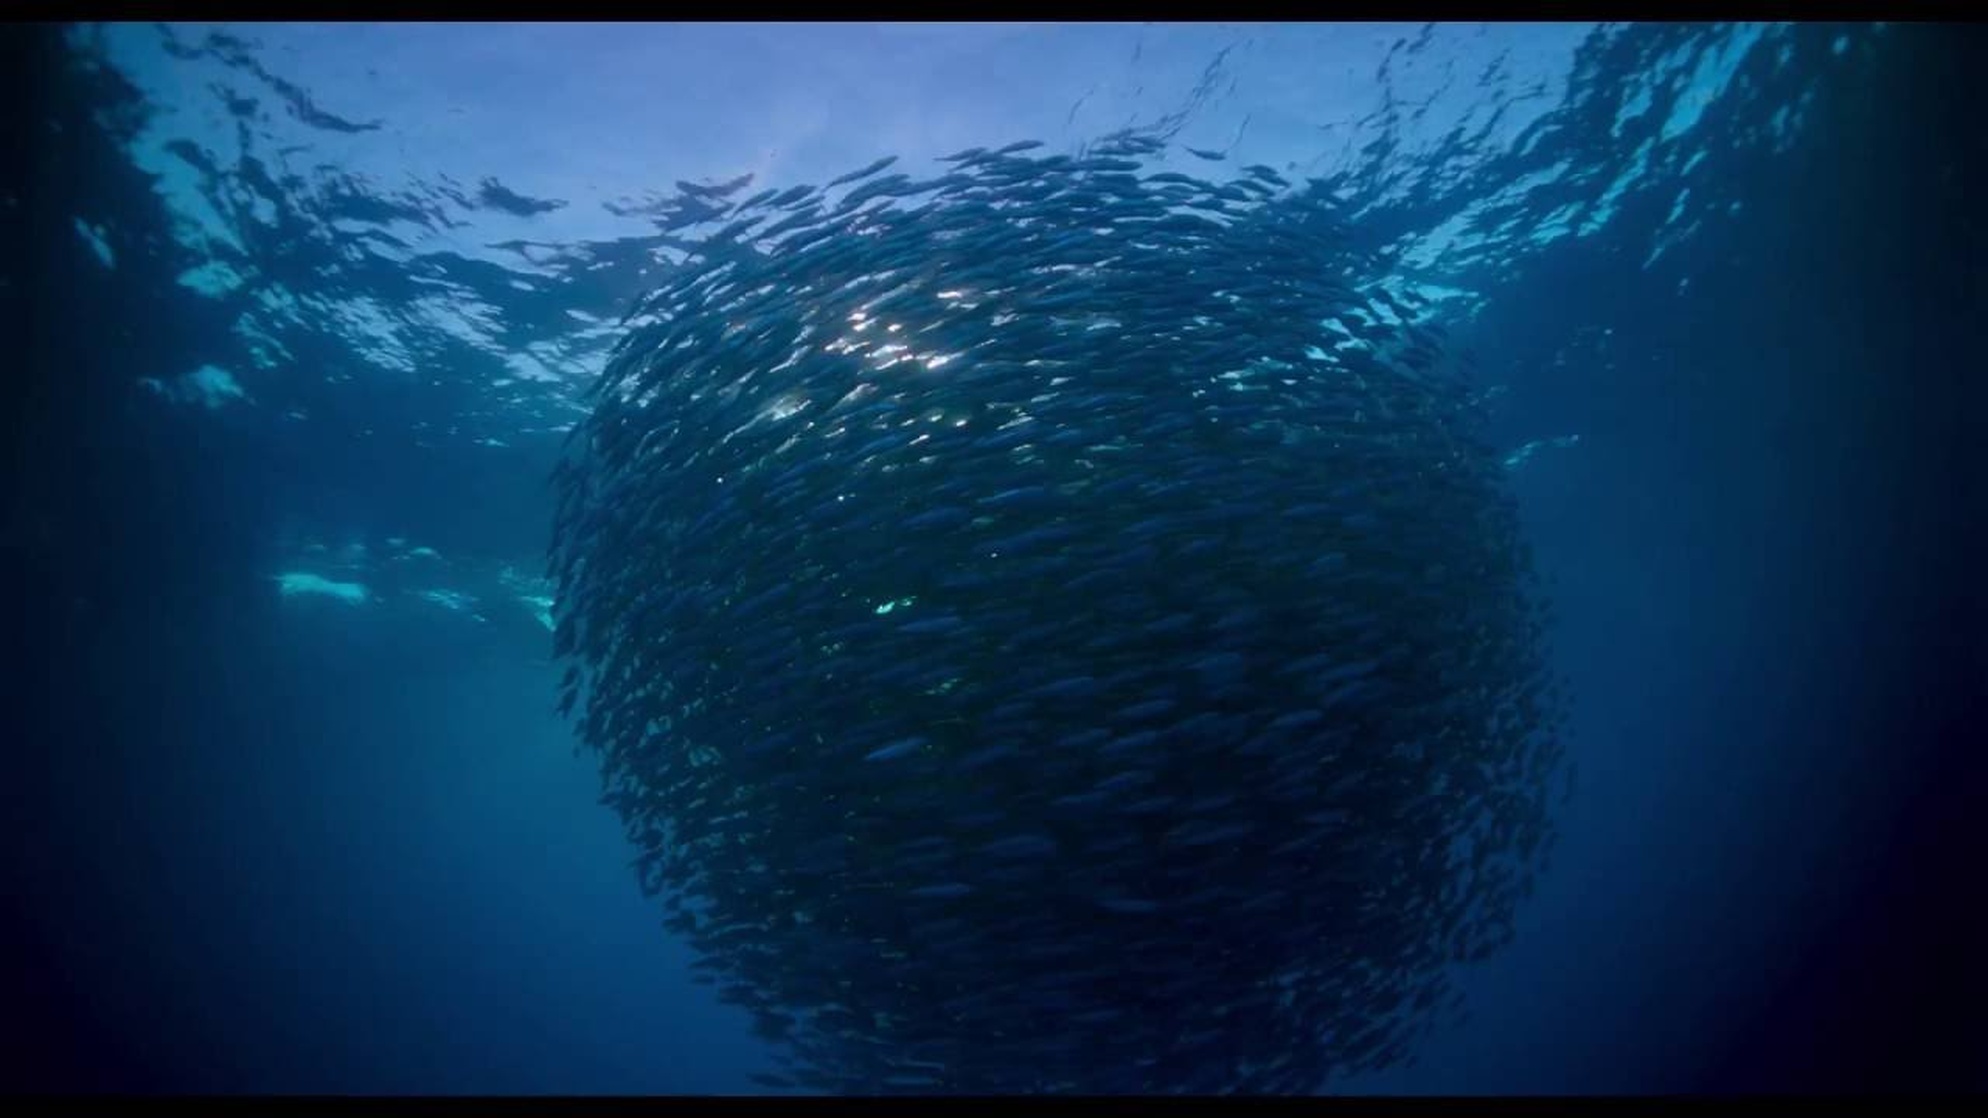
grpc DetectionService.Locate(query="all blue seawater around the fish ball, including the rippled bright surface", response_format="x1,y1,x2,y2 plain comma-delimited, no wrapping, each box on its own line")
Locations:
0,24,1988,1094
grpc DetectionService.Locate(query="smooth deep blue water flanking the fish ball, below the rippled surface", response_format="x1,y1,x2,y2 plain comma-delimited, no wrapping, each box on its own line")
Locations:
0,26,1988,1092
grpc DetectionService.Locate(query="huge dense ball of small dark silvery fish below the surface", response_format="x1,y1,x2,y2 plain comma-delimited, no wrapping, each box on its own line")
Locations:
549,133,1565,1094
